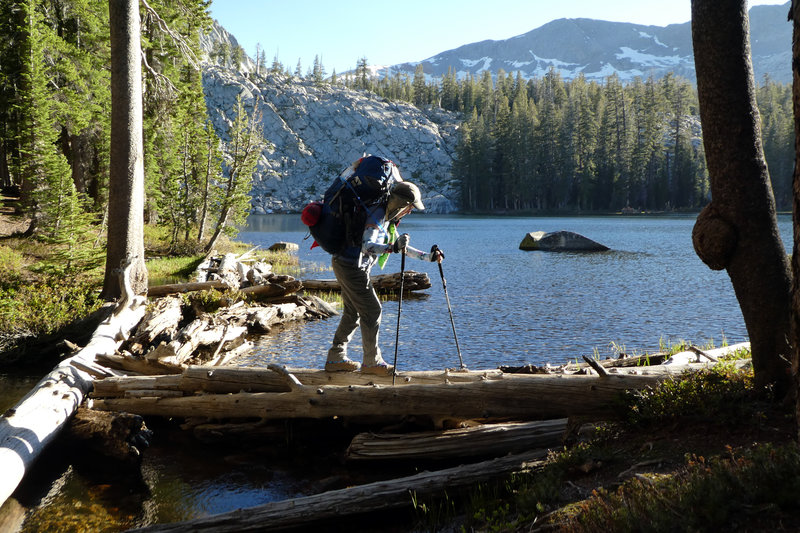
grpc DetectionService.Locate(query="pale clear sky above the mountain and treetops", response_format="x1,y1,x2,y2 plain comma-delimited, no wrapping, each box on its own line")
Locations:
210,0,788,74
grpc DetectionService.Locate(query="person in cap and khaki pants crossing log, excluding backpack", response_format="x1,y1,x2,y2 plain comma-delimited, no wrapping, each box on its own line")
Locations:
325,181,444,375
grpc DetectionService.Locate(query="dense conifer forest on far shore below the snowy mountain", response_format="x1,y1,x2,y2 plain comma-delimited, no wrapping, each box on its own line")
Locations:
260,50,794,211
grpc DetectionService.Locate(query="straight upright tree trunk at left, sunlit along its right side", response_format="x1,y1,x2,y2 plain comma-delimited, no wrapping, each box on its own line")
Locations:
103,0,147,299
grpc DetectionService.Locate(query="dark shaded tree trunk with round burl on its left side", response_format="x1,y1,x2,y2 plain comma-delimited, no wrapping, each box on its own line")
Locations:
692,0,792,394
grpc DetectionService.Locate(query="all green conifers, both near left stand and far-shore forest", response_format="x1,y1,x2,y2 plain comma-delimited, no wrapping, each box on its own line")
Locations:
0,0,794,280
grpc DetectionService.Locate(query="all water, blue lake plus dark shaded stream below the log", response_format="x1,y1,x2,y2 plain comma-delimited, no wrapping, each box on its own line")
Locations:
7,215,791,533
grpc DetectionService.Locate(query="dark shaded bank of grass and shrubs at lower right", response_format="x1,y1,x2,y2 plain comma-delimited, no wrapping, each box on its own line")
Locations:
413,344,800,532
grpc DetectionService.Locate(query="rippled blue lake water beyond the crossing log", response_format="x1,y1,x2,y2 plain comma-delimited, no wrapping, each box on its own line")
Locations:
240,215,791,370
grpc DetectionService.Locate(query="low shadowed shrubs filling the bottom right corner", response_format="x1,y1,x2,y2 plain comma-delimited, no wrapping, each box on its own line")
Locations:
562,444,800,532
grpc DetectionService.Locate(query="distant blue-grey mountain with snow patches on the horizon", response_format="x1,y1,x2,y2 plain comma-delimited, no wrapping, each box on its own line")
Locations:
379,2,792,83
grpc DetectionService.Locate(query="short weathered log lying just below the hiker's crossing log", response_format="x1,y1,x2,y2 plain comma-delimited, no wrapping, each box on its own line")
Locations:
345,418,567,461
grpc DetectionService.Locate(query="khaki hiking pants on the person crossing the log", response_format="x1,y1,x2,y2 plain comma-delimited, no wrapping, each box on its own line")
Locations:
328,257,381,366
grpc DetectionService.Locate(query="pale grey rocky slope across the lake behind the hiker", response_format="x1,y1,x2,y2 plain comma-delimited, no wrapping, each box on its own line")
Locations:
202,25,459,213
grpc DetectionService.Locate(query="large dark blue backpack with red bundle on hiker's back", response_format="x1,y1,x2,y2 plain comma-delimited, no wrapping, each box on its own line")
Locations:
301,155,403,254
